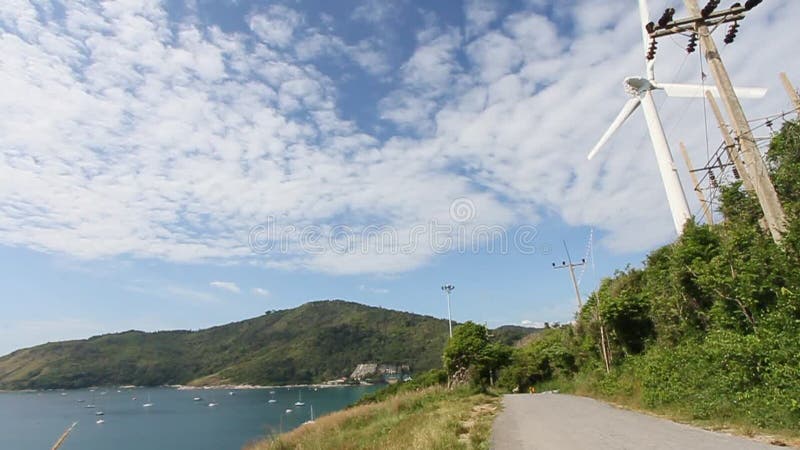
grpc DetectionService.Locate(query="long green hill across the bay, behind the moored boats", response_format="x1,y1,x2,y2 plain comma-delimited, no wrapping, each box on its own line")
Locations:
0,300,536,389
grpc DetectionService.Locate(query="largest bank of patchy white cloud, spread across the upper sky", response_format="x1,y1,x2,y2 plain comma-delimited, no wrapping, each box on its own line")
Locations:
0,0,800,273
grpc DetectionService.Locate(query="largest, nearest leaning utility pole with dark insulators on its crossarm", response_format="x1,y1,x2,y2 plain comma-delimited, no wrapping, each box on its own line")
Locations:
646,0,786,242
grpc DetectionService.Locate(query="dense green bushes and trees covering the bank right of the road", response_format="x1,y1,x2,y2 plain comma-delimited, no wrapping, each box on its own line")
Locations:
500,119,800,435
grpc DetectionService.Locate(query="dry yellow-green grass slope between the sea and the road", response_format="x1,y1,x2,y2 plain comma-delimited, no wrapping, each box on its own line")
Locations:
245,386,500,450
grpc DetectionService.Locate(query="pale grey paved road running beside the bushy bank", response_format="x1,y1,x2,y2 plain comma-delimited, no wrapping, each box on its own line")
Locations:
492,394,785,450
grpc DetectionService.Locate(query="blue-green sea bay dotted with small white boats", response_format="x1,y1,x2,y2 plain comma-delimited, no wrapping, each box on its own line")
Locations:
0,386,375,450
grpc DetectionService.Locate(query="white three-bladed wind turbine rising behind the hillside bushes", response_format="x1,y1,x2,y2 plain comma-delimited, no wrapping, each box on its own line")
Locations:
588,0,767,235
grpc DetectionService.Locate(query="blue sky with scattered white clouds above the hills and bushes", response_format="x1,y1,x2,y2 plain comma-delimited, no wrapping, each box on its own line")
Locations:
0,0,800,354
